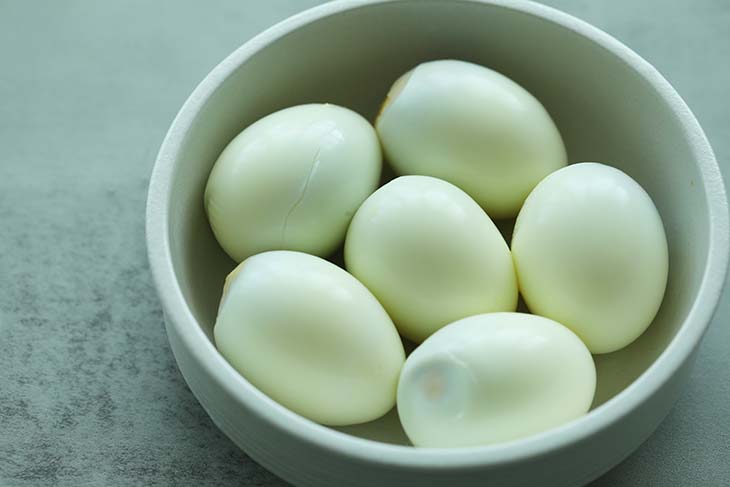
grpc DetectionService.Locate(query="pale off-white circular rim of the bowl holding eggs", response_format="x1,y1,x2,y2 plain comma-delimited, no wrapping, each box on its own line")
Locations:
146,0,728,470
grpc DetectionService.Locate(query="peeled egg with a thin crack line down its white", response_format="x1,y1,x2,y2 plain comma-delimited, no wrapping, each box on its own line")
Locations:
204,104,381,262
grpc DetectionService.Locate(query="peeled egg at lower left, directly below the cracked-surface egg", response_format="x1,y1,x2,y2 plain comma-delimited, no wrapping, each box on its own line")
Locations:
214,251,405,426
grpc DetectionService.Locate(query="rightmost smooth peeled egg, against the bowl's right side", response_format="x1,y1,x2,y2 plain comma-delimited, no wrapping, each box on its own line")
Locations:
512,163,669,354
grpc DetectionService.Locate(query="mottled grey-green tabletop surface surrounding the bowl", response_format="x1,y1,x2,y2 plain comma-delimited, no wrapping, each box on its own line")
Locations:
0,0,730,487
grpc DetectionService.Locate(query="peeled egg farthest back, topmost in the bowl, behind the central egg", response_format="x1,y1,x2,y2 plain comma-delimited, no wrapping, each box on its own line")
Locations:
375,60,566,218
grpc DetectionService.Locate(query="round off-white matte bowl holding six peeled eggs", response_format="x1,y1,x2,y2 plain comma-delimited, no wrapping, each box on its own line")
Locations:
147,0,728,487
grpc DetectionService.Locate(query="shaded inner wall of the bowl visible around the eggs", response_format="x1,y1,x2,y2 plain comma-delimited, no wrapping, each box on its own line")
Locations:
164,1,709,443
